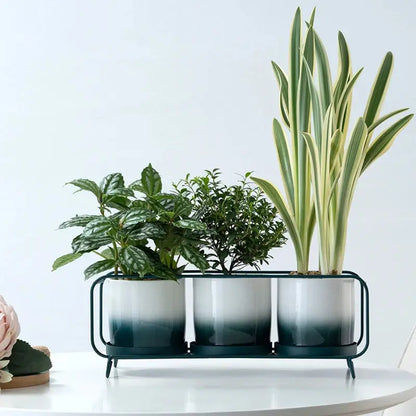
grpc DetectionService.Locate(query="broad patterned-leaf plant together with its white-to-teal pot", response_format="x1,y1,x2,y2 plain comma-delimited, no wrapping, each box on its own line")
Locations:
53,165,208,354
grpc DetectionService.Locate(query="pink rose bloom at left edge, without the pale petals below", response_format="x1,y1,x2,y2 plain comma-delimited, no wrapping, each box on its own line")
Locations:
0,296,20,360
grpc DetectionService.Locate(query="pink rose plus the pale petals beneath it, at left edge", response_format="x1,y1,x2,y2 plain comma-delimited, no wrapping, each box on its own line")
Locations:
0,296,20,383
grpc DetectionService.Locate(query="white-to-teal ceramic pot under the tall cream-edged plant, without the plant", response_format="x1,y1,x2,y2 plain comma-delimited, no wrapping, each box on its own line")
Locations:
277,278,355,347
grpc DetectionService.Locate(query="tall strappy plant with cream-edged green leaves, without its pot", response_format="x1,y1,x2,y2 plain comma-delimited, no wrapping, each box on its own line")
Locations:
253,8,413,274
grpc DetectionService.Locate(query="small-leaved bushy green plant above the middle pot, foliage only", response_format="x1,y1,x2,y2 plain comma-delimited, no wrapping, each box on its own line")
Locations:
175,169,286,274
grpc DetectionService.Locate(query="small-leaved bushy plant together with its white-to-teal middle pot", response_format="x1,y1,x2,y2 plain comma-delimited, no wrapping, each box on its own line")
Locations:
176,169,286,355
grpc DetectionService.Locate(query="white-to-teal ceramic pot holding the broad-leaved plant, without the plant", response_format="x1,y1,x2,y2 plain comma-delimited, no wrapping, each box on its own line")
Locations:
106,279,185,347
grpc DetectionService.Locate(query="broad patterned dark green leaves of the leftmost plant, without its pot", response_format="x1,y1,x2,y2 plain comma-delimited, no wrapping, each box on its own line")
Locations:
52,164,209,279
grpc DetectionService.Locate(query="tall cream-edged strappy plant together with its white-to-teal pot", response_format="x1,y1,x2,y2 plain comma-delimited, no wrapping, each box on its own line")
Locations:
253,8,413,355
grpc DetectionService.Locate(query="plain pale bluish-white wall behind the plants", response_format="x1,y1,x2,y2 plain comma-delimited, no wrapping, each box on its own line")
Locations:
0,0,416,404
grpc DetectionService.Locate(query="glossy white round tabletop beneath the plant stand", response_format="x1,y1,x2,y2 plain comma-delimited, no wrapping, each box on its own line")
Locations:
0,353,416,416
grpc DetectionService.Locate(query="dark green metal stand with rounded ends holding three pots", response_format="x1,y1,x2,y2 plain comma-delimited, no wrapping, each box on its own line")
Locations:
90,271,370,378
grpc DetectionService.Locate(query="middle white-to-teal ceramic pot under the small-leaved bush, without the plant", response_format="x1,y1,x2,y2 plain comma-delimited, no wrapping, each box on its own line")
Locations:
193,277,271,346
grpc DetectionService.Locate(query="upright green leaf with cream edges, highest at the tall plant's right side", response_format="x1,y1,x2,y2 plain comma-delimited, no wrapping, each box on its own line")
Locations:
364,52,393,126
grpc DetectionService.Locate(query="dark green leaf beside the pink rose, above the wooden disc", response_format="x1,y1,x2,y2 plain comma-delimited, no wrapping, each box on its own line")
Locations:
8,339,52,376
